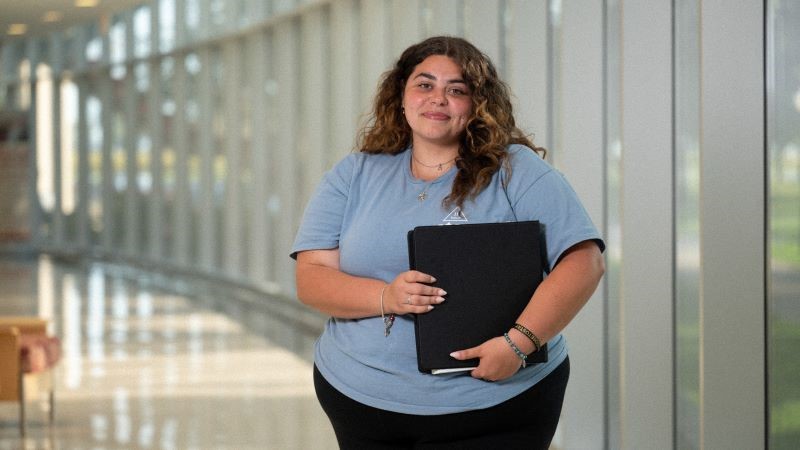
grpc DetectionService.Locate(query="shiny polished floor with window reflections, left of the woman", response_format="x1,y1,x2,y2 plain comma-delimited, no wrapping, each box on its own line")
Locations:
0,257,336,450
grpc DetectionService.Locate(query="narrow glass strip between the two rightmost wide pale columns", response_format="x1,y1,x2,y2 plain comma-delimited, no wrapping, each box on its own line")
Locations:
673,0,700,449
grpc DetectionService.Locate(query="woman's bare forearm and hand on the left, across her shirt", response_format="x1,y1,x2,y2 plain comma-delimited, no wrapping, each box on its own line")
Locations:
295,249,445,319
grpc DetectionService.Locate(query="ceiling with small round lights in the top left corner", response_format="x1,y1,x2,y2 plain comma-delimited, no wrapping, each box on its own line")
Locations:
0,0,149,41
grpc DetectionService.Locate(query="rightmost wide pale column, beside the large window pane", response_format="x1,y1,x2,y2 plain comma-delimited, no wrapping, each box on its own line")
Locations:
700,0,767,449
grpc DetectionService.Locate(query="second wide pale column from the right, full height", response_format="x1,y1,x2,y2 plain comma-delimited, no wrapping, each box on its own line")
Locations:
620,0,674,449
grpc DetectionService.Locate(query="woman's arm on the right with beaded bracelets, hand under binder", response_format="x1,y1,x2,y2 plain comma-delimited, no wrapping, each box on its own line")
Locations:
452,241,605,381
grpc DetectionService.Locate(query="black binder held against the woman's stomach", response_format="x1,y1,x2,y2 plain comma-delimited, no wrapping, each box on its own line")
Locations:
408,221,547,374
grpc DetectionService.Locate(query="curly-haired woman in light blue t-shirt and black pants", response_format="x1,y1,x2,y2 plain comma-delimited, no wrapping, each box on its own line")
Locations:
292,37,604,449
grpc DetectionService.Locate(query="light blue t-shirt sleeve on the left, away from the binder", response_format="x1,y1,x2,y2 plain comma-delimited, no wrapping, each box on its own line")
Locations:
289,155,356,259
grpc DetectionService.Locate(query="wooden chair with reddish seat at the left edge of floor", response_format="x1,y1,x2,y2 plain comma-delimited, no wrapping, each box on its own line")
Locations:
0,316,61,436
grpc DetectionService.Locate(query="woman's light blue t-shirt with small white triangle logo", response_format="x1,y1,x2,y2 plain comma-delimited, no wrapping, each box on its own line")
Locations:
292,145,603,415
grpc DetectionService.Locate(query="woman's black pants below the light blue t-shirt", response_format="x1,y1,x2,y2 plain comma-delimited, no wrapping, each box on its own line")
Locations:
314,359,569,450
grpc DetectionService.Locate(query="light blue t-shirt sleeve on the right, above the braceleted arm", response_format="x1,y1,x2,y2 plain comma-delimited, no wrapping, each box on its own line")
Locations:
509,152,605,269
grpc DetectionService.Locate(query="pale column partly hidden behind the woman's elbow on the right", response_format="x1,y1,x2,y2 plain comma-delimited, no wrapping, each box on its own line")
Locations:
556,0,608,449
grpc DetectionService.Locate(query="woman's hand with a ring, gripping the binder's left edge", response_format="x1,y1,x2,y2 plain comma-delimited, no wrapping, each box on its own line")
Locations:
383,270,447,315
